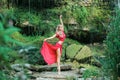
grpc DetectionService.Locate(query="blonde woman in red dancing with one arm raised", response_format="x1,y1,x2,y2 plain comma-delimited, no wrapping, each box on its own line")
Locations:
40,15,66,74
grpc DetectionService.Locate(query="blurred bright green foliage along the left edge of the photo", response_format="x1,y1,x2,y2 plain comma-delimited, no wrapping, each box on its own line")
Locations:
0,10,23,80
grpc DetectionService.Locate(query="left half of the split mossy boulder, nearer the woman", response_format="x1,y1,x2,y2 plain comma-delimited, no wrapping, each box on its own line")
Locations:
66,44,82,59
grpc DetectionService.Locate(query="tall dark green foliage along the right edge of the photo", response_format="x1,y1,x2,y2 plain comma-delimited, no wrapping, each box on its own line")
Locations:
103,8,120,80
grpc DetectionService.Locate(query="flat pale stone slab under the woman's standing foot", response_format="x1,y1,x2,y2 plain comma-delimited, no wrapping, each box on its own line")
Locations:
33,70,81,80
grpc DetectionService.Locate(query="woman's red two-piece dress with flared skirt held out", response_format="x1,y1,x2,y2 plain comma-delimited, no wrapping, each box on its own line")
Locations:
40,32,66,65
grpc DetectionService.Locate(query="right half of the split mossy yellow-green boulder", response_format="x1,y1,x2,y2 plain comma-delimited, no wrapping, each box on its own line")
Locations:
75,46,92,60
